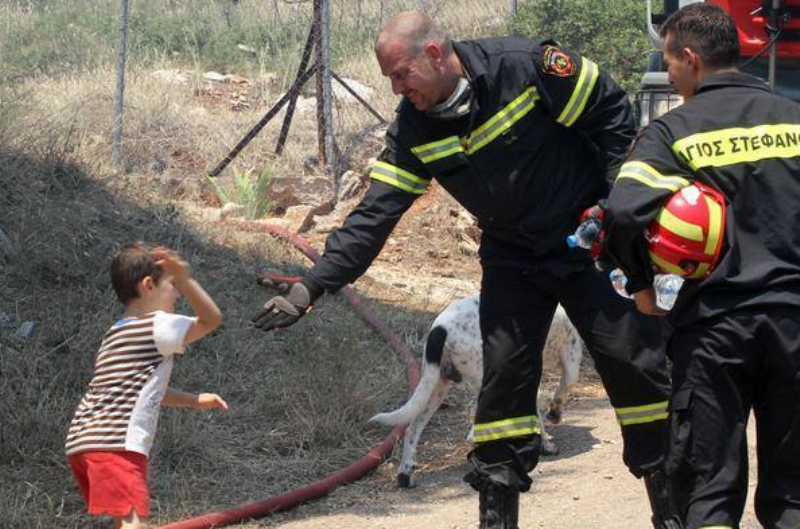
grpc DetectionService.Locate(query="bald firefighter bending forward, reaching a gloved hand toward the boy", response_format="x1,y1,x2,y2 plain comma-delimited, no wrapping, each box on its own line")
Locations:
254,12,678,529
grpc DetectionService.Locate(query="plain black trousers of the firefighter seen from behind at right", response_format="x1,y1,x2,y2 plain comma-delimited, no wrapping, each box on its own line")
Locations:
666,307,800,529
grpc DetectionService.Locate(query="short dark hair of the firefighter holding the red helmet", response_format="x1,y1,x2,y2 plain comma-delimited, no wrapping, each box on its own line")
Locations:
659,3,739,69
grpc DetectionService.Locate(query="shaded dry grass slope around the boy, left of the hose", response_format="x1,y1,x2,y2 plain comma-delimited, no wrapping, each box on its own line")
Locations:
0,142,438,527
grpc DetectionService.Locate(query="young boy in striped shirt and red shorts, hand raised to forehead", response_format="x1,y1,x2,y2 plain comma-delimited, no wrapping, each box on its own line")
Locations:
66,242,228,529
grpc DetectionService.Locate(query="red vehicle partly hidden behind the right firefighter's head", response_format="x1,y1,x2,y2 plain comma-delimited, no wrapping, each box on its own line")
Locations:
636,0,800,126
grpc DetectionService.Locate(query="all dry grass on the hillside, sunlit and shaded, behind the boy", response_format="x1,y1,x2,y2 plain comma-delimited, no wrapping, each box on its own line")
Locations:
0,0,512,528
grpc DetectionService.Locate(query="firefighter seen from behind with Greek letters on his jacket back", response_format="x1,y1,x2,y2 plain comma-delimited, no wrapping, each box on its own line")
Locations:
606,4,800,529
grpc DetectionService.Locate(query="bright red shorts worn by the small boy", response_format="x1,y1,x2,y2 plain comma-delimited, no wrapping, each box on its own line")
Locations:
67,452,150,516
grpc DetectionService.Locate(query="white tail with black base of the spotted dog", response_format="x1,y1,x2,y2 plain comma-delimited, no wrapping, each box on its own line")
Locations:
370,326,447,426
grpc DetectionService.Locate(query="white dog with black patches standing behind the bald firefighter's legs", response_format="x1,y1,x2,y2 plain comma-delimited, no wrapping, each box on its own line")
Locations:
370,295,583,488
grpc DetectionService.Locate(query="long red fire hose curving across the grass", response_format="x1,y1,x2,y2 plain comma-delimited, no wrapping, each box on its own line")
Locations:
155,222,419,529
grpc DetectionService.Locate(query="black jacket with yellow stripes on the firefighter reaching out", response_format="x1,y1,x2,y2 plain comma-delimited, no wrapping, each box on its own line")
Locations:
312,38,633,291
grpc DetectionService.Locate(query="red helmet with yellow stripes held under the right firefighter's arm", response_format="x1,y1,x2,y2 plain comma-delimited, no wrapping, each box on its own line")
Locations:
645,182,725,279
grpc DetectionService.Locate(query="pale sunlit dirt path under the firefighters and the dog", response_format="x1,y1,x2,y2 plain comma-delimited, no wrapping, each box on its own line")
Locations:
246,381,759,529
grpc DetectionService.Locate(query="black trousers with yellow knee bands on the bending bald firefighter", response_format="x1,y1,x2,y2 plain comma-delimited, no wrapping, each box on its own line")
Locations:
465,266,670,491
